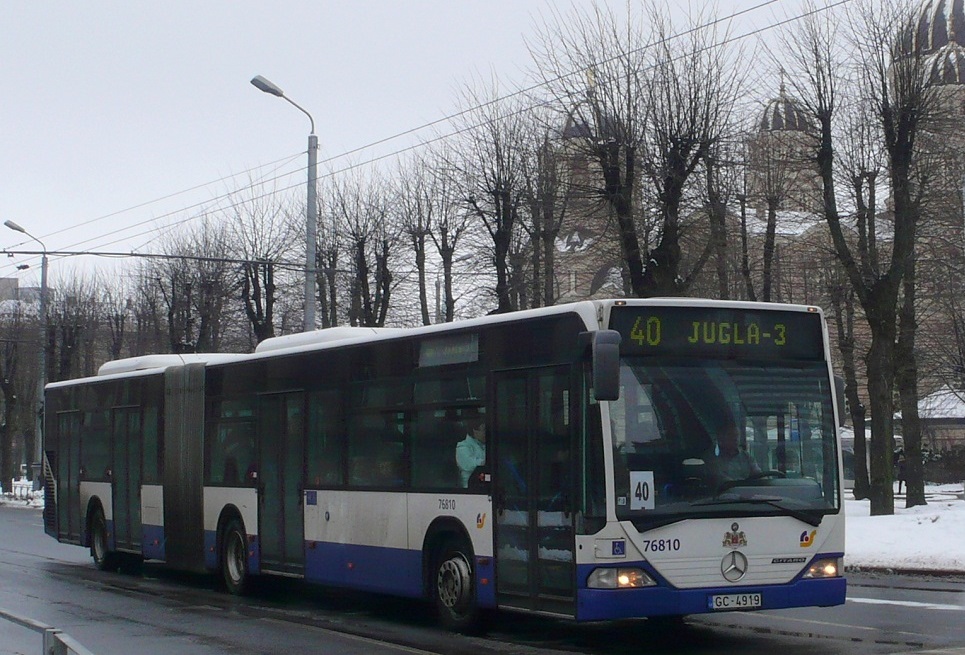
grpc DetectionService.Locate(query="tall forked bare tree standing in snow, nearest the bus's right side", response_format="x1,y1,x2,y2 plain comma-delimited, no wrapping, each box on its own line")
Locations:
790,3,932,514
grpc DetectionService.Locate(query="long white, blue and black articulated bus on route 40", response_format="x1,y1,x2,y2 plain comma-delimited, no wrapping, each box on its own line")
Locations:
44,299,846,630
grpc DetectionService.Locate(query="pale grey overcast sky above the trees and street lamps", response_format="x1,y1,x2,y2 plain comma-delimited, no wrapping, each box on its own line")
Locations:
0,0,812,285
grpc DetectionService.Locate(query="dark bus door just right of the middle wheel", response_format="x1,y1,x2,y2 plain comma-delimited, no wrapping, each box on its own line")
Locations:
258,391,305,573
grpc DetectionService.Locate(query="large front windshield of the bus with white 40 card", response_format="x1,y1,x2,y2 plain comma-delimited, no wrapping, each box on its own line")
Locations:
610,356,840,529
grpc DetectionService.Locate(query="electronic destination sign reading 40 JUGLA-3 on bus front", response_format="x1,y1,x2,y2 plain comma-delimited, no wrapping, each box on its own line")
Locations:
610,307,824,360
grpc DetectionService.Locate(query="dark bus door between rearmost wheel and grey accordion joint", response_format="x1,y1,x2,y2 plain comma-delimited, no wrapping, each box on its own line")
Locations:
111,407,141,551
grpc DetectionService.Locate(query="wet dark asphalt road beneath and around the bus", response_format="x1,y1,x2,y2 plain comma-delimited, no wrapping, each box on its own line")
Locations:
0,506,965,655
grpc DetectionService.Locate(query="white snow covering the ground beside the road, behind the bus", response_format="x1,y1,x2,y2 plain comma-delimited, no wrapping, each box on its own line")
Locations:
0,484,965,574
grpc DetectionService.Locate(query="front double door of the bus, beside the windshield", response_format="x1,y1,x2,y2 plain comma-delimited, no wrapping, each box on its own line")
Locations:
491,366,576,615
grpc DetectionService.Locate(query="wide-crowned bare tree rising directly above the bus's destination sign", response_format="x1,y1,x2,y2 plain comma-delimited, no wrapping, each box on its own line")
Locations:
535,6,741,296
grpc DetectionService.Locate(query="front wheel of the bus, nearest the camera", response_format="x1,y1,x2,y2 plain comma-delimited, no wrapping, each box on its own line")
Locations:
433,539,482,632
